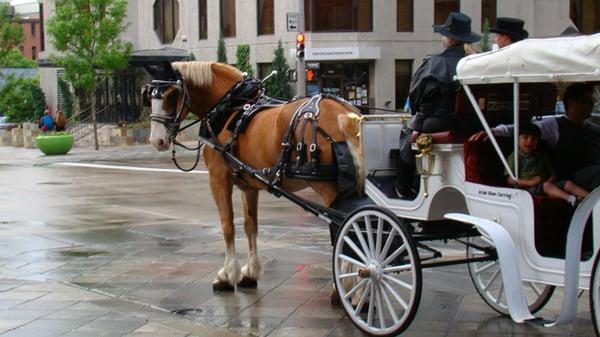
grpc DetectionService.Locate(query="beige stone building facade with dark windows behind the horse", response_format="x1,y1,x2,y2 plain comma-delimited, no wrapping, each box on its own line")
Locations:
41,0,600,113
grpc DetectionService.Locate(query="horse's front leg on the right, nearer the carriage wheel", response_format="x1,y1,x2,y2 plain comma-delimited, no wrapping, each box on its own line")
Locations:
238,189,262,288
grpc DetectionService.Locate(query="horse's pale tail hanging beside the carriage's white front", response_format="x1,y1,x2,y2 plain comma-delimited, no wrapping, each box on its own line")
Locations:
338,109,365,194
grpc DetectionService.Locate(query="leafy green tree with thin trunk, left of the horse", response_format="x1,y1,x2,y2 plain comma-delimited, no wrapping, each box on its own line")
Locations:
47,0,133,149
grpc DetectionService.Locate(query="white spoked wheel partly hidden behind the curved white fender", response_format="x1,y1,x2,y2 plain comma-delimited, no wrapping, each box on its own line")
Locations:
467,236,555,316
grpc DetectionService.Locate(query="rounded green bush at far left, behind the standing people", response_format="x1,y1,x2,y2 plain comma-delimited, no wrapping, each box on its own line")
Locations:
0,77,46,123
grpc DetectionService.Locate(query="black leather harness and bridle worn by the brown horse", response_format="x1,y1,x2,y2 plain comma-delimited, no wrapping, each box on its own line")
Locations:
149,72,354,195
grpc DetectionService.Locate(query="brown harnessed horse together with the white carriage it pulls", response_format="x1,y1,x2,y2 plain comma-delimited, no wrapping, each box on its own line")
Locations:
148,34,600,336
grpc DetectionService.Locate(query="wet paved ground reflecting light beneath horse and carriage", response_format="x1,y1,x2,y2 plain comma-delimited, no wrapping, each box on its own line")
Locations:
0,146,593,337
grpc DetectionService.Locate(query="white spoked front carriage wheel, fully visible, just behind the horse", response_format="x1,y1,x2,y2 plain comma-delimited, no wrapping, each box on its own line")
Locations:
333,206,422,336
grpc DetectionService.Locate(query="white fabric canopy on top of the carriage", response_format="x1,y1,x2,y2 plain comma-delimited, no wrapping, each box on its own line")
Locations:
456,33,600,84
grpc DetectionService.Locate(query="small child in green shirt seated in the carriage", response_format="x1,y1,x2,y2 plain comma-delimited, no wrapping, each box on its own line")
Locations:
504,123,588,206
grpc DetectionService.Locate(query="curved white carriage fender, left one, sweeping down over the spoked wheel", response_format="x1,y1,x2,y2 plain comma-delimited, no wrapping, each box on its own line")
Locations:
444,213,535,323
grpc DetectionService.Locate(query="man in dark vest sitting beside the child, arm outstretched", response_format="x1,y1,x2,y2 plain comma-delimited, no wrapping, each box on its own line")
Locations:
469,83,600,191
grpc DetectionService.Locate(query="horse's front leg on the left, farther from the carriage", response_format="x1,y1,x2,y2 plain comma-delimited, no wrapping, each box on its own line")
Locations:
205,164,240,291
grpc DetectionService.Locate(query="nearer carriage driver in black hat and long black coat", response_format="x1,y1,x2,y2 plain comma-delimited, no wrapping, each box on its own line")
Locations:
396,12,481,199
